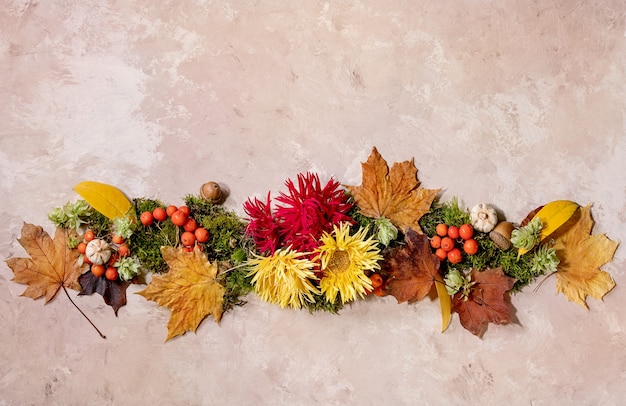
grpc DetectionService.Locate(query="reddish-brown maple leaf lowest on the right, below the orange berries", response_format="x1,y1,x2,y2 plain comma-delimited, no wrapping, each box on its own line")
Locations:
452,268,515,337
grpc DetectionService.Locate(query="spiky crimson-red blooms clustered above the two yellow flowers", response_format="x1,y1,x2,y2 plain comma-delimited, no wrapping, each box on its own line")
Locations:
244,172,354,253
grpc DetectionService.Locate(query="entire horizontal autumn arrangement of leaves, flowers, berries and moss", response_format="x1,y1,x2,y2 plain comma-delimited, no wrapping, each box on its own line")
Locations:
6,148,618,340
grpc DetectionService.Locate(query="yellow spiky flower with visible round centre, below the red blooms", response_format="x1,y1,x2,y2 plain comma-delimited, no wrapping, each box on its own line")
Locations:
316,222,383,303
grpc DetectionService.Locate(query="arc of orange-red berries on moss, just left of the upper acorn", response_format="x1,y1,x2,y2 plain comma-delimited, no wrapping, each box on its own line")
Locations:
139,205,209,251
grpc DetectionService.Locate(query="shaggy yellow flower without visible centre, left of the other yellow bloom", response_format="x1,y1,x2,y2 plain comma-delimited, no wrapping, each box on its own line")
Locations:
250,248,319,309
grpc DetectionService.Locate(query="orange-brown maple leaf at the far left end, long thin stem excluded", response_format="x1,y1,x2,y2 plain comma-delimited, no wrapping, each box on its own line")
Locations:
6,223,81,303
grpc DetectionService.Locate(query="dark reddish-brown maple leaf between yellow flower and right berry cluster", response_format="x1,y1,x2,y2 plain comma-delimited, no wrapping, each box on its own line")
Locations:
381,230,440,303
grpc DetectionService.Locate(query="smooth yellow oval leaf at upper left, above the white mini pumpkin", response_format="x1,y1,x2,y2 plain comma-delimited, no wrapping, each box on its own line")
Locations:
74,181,132,219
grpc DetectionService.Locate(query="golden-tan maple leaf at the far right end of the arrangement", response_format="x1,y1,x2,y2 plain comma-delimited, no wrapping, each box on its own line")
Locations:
554,205,619,308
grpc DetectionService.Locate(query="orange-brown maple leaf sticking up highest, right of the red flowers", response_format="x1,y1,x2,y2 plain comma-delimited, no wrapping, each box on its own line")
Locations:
346,147,441,234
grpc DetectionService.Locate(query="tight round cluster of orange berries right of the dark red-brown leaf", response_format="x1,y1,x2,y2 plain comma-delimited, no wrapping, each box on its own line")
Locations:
430,223,478,264
